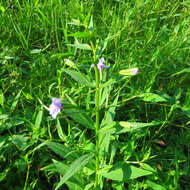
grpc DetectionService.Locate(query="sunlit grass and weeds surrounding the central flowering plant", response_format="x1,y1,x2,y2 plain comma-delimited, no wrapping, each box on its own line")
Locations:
0,0,190,190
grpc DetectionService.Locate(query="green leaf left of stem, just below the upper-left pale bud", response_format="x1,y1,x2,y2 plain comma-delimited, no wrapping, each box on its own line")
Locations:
63,69,95,87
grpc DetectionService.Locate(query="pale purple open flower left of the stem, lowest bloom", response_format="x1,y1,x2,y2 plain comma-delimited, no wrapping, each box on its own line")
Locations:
49,98,62,119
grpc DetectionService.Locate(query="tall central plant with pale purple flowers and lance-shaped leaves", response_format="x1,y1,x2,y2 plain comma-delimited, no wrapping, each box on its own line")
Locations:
37,13,157,190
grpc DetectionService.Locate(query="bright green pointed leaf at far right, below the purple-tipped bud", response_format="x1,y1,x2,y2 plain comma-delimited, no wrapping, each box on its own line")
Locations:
139,93,167,102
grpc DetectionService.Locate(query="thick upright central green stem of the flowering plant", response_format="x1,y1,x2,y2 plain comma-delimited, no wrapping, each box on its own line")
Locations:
95,66,100,187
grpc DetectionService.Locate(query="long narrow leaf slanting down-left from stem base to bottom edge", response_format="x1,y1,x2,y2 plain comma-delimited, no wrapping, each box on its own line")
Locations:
55,154,93,190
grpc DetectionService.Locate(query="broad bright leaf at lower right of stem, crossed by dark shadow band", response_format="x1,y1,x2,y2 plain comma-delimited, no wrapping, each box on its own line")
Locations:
98,162,152,181
